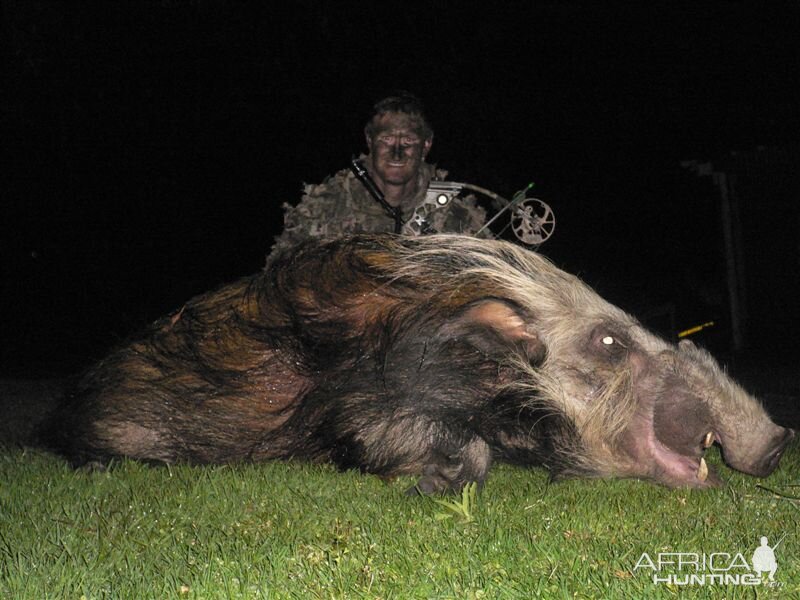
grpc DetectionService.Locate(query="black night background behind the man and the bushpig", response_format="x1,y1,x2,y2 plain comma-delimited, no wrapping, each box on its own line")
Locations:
0,0,800,394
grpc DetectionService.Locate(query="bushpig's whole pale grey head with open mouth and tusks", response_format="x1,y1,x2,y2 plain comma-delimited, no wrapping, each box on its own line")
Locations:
450,243,794,488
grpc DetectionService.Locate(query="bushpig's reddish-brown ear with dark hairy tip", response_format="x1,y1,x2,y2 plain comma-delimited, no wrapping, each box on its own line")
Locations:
442,299,547,364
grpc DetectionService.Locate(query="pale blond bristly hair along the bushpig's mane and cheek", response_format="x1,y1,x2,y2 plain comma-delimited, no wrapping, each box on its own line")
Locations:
334,235,648,476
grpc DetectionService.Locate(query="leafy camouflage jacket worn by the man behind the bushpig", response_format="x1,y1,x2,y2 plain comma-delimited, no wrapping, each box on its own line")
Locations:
272,158,488,254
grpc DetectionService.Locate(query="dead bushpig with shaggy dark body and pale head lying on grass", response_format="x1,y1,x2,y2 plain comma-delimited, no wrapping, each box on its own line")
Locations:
41,235,794,493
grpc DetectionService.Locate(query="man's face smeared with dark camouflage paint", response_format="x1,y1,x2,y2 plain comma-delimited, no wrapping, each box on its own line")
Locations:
367,112,433,185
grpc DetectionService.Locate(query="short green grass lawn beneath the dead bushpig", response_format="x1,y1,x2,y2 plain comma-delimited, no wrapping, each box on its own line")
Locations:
0,446,800,600
